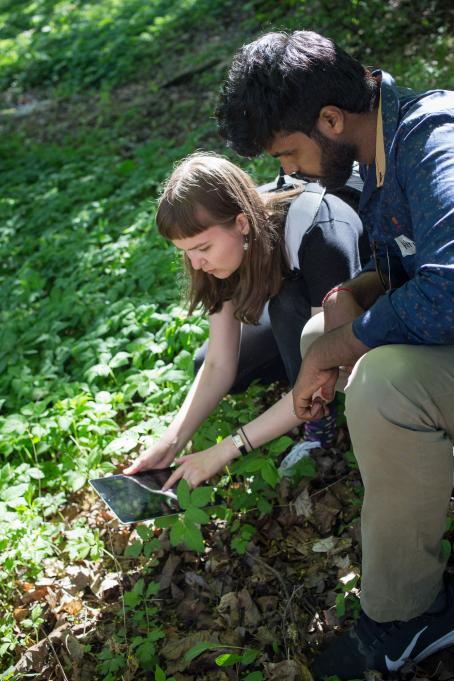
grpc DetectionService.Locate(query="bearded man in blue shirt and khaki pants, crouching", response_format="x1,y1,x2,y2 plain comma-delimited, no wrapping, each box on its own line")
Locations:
217,31,454,679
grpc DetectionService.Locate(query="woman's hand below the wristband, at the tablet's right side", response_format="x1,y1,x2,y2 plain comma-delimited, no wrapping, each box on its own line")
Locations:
162,437,239,490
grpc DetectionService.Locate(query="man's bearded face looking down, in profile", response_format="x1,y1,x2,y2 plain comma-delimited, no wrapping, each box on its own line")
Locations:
266,128,357,191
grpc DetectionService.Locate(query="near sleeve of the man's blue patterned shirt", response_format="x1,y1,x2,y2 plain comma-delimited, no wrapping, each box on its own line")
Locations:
353,111,454,348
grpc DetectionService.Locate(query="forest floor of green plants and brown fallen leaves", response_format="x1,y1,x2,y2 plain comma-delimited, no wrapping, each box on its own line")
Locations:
0,0,454,681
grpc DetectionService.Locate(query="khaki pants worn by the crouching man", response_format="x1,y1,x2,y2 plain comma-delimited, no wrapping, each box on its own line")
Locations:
301,314,454,622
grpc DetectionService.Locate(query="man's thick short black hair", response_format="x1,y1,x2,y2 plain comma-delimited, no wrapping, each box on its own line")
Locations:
216,31,377,156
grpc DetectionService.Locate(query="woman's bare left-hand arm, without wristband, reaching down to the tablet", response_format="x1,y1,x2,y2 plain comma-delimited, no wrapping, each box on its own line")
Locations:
124,302,241,475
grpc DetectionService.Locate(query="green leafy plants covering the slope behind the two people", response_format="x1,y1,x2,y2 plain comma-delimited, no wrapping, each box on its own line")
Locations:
0,0,454,679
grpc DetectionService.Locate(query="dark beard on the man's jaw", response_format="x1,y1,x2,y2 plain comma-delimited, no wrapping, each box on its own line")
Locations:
310,128,357,191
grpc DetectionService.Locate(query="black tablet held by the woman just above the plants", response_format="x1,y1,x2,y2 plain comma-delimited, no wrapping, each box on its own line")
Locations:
89,468,181,524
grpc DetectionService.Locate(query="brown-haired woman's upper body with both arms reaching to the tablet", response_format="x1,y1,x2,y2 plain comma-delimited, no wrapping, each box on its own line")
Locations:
124,153,367,488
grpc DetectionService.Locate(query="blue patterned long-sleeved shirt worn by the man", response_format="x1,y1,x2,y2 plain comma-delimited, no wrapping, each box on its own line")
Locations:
353,72,454,348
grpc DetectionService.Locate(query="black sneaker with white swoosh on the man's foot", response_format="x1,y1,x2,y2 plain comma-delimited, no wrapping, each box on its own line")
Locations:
312,578,454,681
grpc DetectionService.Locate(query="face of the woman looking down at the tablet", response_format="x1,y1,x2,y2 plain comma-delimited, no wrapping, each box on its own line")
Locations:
172,213,249,279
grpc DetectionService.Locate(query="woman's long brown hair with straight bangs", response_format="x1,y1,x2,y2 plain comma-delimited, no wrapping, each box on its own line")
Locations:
156,153,295,324
